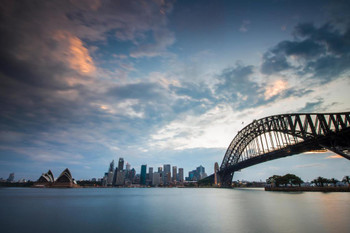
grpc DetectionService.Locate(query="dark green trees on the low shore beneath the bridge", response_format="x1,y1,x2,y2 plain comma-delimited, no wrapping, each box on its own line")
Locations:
266,174,350,187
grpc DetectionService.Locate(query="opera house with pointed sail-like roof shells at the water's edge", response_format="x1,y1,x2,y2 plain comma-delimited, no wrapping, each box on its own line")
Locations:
34,168,78,188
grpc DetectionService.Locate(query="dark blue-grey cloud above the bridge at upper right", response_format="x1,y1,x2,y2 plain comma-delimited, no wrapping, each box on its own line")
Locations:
261,23,350,84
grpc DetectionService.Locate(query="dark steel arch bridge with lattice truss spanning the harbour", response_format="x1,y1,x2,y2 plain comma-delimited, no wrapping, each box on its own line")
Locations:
215,112,350,186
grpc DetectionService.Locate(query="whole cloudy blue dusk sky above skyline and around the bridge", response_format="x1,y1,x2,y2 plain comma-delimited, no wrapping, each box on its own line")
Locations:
0,0,350,180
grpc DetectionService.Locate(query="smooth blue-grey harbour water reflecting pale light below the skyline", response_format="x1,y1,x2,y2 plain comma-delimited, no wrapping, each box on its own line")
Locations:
0,188,350,233
